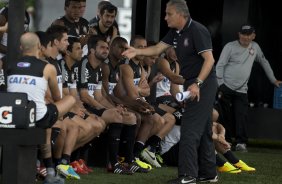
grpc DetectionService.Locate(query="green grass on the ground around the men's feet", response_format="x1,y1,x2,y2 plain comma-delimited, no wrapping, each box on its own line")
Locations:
61,148,282,184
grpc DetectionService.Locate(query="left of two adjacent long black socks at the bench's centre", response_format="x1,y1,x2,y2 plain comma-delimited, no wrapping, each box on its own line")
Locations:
108,123,123,166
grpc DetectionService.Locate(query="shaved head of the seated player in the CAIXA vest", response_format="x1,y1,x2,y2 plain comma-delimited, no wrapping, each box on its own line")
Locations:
20,32,40,53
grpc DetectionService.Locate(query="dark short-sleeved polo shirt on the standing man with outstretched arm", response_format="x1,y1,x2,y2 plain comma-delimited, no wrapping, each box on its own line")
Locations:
162,19,212,80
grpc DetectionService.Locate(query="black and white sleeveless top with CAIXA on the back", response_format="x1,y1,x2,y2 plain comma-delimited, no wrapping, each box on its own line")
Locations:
7,56,48,121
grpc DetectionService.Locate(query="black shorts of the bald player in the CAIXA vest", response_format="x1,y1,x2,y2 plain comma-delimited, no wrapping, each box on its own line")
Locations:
36,103,59,129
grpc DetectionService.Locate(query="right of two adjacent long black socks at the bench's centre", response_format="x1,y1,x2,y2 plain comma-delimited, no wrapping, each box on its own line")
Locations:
122,125,136,163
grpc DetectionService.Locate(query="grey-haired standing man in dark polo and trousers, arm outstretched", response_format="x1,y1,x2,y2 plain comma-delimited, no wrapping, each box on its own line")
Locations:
123,0,218,184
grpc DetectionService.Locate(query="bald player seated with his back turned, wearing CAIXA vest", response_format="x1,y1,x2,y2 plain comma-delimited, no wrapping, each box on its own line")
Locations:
7,32,75,184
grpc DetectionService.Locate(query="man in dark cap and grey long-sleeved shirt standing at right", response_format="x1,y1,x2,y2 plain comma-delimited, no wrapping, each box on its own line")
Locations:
216,24,281,152
